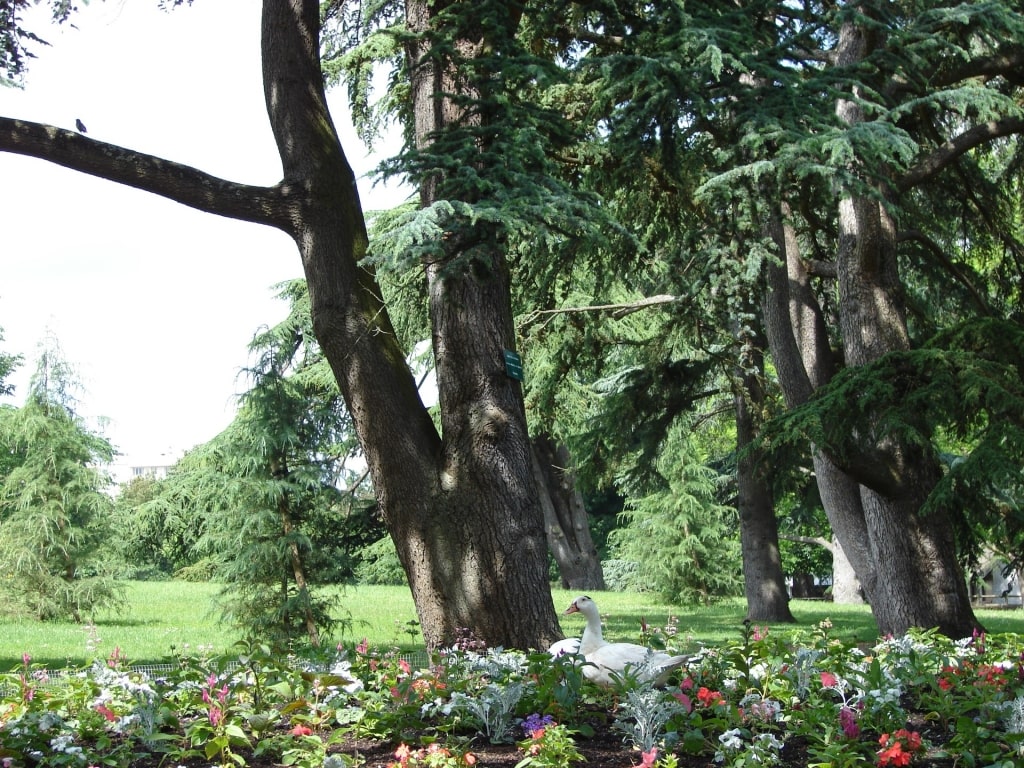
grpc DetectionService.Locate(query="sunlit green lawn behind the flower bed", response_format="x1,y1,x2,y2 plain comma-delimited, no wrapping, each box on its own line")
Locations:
0,582,1024,672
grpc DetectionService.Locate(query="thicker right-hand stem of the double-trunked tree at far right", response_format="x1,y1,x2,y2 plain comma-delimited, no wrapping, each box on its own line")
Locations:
819,24,979,637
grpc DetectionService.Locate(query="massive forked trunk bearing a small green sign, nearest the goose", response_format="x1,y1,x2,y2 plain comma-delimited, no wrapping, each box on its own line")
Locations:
263,0,561,649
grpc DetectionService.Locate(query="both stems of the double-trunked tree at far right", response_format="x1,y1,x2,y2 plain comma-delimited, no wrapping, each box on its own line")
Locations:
765,176,977,637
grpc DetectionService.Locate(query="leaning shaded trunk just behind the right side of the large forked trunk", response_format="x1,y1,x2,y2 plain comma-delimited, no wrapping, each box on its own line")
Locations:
532,434,605,592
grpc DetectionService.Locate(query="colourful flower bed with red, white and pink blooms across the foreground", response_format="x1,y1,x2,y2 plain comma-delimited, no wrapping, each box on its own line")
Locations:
0,623,1024,768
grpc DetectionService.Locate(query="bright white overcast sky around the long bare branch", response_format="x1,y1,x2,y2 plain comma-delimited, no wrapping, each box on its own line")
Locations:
0,0,406,462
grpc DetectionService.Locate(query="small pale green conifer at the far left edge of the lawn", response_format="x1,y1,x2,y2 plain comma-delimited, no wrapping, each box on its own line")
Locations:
0,344,121,621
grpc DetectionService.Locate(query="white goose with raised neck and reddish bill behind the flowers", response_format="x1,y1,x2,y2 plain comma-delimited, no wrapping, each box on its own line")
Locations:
565,595,690,687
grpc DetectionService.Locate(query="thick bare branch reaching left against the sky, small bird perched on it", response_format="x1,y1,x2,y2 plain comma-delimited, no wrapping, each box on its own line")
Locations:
0,117,295,231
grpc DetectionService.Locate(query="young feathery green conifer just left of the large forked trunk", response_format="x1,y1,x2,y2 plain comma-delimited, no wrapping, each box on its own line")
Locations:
140,282,372,644
